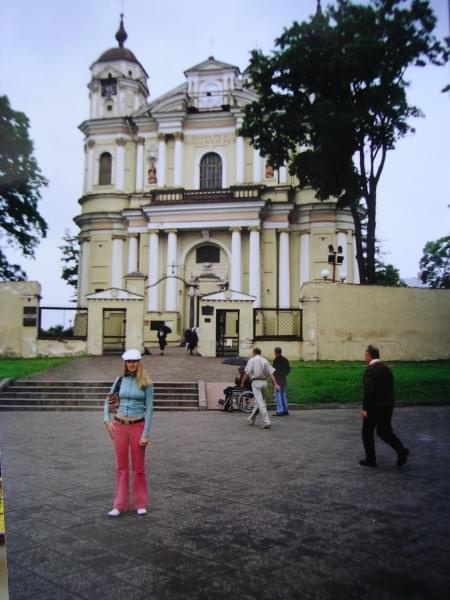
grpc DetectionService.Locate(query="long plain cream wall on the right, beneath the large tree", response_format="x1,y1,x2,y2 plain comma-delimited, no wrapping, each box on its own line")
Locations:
301,282,450,360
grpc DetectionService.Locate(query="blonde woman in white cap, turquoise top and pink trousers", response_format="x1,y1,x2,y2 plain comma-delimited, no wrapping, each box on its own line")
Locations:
103,350,153,517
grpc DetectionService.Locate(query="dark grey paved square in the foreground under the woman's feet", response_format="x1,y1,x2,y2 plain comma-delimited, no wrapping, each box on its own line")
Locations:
0,406,450,600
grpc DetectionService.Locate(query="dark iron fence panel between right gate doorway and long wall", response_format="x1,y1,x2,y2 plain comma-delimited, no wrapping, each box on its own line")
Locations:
253,308,302,341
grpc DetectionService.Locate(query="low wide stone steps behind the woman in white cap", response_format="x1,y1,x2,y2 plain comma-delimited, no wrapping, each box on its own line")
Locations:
0,379,200,411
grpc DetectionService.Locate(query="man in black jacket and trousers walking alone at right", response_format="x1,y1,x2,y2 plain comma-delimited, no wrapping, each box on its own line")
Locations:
359,346,409,467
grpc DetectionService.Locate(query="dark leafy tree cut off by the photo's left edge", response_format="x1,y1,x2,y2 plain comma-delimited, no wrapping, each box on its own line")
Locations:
0,96,48,280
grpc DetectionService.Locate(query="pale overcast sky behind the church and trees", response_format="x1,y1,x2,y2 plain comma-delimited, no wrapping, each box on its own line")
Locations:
0,0,450,306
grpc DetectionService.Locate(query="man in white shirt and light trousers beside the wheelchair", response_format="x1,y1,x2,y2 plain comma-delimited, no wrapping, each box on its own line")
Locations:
241,348,279,429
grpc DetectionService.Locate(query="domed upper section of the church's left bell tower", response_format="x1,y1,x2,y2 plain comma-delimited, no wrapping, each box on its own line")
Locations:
88,14,149,119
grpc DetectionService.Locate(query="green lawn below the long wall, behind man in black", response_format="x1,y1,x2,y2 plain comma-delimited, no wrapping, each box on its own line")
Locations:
278,361,450,404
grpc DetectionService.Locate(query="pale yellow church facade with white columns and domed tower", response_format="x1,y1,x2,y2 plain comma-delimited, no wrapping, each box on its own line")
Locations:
75,22,358,355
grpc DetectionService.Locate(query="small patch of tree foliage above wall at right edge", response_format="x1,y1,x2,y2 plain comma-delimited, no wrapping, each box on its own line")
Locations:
419,235,450,290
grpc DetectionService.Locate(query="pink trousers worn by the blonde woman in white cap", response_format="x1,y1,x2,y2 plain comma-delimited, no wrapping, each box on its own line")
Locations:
114,421,148,510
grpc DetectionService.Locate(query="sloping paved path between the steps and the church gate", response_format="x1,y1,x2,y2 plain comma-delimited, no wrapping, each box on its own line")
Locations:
25,347,239,382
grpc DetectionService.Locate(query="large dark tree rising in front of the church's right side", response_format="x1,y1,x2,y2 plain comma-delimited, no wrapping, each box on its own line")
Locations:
241,0,450,284
